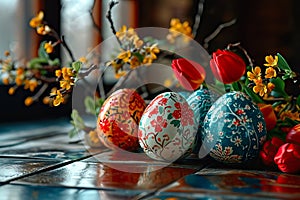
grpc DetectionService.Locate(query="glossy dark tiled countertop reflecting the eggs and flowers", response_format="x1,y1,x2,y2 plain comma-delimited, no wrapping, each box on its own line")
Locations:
0,119,300,200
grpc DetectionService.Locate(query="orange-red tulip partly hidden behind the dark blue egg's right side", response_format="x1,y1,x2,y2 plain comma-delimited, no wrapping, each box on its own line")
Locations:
258,104,277,131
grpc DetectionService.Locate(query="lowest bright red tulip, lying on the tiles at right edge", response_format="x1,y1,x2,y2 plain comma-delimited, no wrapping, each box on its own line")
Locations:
274,143,300,173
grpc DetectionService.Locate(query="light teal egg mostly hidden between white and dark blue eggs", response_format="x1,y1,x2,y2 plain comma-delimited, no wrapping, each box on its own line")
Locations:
187,88,219,153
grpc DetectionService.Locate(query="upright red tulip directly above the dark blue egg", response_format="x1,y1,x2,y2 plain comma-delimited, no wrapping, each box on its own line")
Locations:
210,49,246,84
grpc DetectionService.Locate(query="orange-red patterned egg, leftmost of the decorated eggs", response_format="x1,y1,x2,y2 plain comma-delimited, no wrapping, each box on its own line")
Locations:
97,88,146,151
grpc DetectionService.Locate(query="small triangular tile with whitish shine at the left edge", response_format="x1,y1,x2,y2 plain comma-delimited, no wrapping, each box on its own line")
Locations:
0,158,59,182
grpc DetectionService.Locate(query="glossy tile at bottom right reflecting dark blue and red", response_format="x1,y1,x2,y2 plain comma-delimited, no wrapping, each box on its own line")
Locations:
158,168,300,199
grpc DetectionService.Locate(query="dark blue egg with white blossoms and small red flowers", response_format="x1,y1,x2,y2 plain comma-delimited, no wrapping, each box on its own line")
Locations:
199,91,266,163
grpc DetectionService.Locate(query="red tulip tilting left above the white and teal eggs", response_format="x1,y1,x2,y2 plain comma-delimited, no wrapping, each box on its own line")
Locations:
172,58,206,91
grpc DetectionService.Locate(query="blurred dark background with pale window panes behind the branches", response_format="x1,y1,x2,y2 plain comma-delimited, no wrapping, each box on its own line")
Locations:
0,0,300,123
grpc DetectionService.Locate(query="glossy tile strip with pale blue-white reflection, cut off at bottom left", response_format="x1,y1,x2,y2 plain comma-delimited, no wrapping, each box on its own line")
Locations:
0,185,138,200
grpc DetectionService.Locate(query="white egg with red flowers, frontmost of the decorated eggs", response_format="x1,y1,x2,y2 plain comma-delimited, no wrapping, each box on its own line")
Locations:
138,92,197,162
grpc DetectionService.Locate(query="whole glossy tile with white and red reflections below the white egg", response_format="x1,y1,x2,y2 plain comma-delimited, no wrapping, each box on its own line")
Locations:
14,162,195,190
